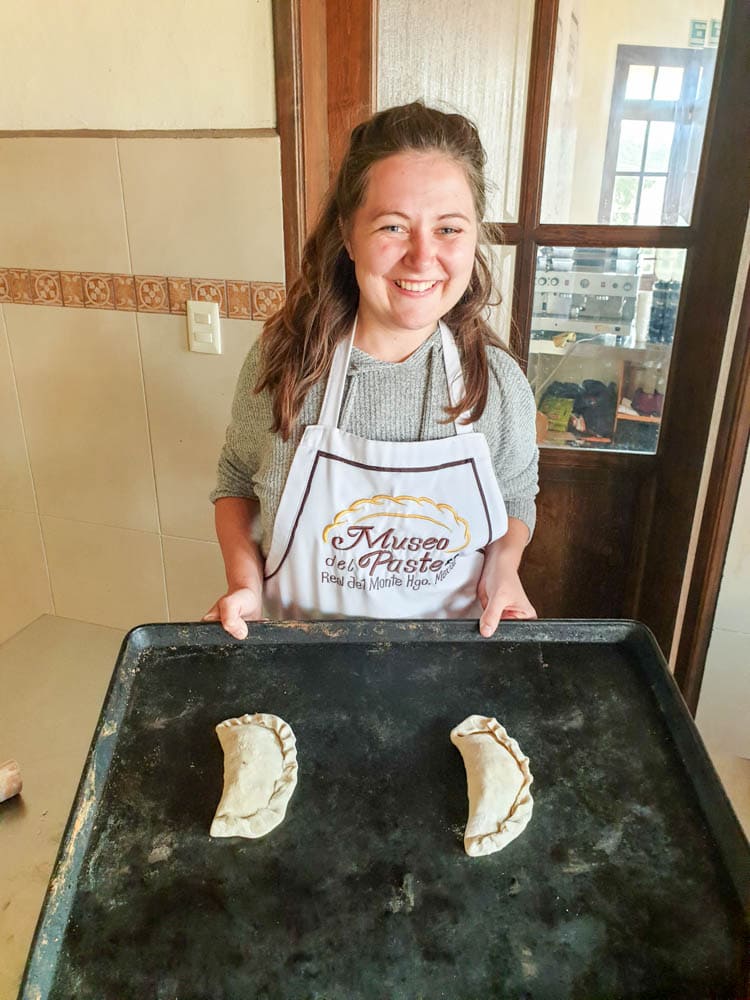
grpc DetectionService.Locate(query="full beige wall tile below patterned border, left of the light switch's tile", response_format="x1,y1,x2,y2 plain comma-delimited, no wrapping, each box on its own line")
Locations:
5,305,158,531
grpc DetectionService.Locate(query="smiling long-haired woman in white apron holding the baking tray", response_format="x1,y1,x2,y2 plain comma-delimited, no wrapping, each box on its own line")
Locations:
206,102,538,638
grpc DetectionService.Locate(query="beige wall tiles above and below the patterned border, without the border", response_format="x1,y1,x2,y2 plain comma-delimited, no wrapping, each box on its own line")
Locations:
0,137,284,641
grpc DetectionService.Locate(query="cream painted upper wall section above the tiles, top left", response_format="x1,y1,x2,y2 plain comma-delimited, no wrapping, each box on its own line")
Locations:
0,0,275,130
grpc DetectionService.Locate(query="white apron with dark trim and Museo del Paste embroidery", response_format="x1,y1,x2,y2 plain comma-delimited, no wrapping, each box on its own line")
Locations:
264,322,508,619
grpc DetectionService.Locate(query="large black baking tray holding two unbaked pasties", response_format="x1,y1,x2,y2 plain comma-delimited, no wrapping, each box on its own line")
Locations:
20,620,750,1000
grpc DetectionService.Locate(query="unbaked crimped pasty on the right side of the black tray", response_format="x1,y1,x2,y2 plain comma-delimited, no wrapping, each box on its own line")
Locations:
451,715,534,857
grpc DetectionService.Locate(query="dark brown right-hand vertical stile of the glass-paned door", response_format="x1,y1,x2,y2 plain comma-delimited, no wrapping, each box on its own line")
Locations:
636,0,750,656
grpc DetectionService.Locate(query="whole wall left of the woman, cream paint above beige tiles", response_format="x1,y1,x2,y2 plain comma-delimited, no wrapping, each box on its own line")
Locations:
0,0,284,641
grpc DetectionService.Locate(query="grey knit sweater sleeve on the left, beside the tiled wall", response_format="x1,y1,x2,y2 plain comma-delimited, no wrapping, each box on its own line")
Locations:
209,341,272,503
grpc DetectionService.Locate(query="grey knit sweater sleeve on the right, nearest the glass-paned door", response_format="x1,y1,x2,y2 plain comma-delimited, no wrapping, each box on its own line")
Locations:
479,347,539,538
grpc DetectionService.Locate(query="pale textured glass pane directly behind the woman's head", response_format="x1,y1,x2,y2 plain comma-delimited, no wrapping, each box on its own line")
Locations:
376,0,534,222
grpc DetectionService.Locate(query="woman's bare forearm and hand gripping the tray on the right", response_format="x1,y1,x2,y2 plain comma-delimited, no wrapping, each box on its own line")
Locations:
477,517,536,638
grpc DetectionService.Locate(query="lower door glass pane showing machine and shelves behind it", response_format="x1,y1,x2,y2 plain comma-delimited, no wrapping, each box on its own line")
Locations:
528,247,685,454
